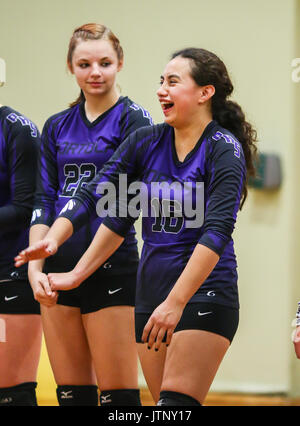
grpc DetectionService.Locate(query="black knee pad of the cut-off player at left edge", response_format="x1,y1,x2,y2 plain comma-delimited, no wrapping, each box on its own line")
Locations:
0,382,37,407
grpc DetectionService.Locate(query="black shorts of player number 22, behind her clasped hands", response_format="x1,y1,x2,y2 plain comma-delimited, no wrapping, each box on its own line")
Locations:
57,271,136,314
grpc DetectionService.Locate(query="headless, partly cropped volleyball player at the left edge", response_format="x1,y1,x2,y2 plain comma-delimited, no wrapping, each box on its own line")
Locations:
0,105,42,407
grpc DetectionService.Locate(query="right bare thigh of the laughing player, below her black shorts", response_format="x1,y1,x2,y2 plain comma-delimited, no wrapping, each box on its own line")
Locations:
161,330,230,404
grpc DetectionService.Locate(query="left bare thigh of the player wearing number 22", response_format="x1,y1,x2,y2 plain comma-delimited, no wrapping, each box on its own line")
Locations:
41,305,96,385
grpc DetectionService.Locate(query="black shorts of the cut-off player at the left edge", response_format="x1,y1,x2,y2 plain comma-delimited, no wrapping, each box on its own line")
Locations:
0,280,40,314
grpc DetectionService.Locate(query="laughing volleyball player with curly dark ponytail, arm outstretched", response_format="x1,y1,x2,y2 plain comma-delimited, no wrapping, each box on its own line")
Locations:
16,48,256,406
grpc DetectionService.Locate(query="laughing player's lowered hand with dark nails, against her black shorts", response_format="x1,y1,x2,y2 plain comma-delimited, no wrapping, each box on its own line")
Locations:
142,299,184,351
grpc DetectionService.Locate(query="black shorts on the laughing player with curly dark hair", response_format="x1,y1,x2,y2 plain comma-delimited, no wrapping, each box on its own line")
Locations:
135,302,239,343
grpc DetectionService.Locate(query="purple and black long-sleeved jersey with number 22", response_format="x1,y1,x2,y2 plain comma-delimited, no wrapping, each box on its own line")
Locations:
31,97,152,274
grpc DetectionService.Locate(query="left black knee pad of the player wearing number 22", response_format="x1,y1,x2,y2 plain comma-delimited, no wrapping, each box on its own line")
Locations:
56,385,98,407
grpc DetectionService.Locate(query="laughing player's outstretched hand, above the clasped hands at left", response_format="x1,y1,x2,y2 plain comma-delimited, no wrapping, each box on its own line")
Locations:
15,238,57,268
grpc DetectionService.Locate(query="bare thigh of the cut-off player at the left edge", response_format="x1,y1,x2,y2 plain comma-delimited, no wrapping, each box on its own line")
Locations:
0,314,42,387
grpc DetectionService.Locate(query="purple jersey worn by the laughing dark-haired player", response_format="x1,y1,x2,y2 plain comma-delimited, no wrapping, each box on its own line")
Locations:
60,121,246,313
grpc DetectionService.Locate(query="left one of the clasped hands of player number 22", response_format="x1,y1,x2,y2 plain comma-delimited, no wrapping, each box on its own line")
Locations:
29,271,58,307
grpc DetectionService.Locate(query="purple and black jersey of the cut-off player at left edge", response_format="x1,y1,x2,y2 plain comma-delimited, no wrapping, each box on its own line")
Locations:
0,106,40,281
